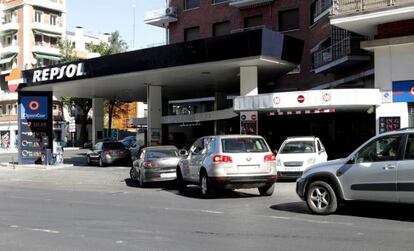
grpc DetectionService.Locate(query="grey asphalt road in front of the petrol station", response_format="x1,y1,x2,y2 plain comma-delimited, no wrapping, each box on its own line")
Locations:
0,152,414,250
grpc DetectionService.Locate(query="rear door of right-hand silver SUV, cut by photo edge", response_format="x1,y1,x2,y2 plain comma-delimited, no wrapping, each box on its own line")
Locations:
397,134,414,203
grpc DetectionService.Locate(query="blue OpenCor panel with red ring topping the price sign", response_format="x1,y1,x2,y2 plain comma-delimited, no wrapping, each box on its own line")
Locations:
20,96,48,120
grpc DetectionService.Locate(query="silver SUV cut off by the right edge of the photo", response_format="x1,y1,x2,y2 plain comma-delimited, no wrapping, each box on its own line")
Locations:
296,129,414,214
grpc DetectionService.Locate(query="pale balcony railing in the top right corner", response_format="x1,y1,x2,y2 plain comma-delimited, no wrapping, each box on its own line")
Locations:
333,0,414,15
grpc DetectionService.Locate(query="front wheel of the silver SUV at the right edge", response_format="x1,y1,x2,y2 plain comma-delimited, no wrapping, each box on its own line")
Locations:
306,181,338,215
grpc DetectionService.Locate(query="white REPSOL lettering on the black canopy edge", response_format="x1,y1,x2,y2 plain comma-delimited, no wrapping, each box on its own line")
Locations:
32,63,85,83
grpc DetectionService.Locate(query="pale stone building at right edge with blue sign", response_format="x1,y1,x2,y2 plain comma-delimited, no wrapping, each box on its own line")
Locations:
330,0,414,133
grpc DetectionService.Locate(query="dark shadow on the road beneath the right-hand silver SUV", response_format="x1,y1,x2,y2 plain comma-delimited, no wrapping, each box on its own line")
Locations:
270,202,414,222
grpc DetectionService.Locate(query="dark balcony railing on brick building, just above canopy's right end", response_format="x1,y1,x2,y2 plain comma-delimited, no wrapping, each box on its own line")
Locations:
313,37,367,69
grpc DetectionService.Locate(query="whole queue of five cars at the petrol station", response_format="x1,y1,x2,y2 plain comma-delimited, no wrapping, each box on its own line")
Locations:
87,129,414,214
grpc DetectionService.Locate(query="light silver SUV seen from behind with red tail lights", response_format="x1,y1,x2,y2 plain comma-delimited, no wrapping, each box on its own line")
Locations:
177,135,277,197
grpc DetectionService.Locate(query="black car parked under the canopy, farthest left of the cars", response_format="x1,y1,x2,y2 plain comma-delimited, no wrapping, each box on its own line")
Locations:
86,141,131,166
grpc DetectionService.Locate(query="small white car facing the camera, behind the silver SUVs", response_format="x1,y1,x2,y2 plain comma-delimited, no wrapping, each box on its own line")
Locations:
276,137,328,178
